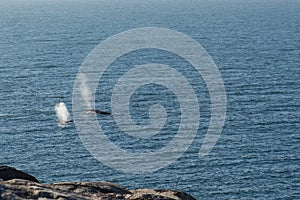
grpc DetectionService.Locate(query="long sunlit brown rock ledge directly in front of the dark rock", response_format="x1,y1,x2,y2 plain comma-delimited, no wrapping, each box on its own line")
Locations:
0,179,130,200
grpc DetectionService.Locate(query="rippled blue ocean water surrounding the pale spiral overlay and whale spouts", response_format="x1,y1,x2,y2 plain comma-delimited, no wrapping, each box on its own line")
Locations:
0,0,300,199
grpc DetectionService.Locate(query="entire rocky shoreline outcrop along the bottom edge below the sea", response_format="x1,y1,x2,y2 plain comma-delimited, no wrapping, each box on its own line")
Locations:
0,168,195,200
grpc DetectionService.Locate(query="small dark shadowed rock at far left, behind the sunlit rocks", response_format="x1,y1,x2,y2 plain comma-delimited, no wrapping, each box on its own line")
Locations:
0,166,39,183
